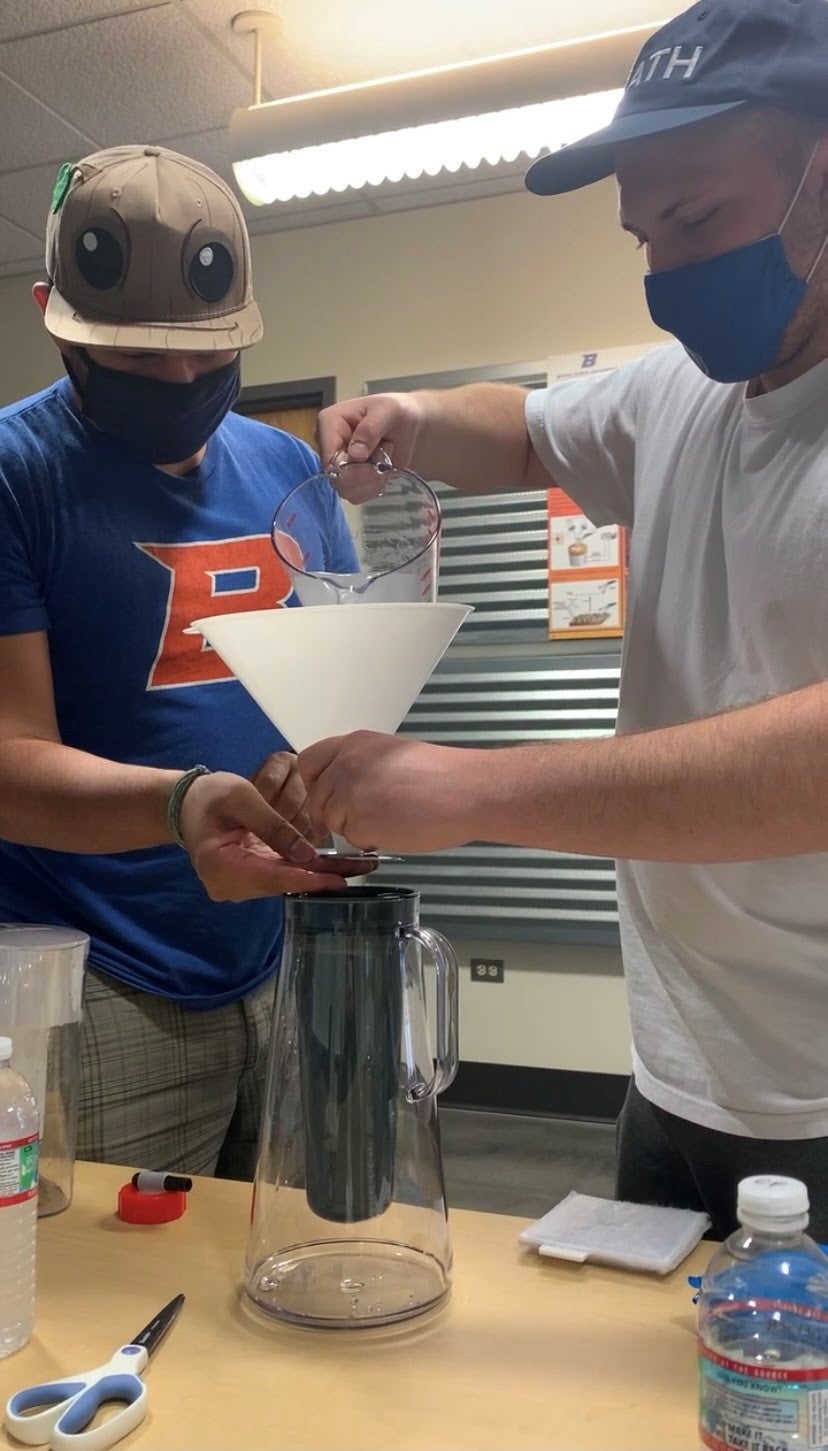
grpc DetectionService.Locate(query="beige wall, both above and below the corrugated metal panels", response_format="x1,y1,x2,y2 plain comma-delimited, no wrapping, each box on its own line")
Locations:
0,183,657,1072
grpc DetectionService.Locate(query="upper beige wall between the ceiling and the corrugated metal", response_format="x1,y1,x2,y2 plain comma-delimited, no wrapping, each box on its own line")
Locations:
0,183,658,403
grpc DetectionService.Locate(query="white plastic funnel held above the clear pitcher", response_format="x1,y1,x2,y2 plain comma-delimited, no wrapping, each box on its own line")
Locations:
191,604,471,752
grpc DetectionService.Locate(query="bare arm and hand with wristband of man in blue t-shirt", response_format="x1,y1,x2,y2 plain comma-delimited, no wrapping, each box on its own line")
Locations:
0,631,361,901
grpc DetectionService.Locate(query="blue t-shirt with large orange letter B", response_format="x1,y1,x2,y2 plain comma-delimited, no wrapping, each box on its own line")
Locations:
0,380,352,1007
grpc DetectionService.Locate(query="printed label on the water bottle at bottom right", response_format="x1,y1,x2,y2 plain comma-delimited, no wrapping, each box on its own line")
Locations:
699,1329,828,1451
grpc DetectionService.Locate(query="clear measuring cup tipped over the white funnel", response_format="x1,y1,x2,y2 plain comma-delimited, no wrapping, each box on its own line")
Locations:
271,448,442,605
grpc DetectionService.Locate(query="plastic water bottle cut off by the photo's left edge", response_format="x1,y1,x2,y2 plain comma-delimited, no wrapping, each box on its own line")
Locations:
0,1037,41,1357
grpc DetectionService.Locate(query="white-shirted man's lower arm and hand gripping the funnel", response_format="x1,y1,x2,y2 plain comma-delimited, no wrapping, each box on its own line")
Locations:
299,683,828,863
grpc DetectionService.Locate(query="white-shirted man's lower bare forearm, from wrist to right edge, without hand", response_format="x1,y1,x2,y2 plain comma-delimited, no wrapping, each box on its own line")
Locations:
473,683,828,863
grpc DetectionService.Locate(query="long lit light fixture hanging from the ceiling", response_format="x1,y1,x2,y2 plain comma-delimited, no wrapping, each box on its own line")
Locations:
231,12,664,206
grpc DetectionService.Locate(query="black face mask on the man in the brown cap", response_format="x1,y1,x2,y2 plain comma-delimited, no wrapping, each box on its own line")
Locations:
64,348,241,464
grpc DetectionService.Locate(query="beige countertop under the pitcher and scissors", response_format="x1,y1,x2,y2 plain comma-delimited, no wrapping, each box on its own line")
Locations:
0,1164,711,1451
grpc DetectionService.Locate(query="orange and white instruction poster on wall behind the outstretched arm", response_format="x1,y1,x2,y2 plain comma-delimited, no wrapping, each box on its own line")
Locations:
548,344,658,640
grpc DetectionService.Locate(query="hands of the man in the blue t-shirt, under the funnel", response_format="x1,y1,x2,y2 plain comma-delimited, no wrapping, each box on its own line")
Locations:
180,756,345,903
